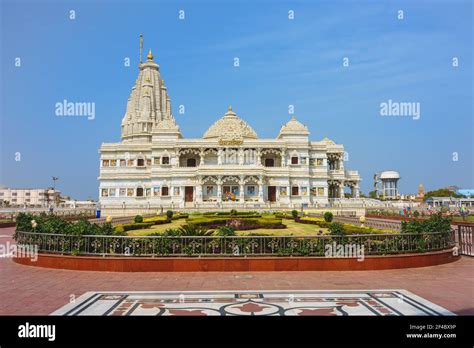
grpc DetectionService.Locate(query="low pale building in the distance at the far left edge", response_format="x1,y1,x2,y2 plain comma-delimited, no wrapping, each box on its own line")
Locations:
0,187,61,208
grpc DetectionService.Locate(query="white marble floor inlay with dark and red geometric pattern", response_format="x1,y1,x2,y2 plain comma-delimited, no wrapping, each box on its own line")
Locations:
52,289,454,316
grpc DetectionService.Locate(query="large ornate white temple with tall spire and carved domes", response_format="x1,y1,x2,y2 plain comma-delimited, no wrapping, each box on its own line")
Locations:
98,37,361,213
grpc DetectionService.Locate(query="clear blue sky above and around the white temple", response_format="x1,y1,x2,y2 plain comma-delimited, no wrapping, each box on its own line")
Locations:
0,0,474,199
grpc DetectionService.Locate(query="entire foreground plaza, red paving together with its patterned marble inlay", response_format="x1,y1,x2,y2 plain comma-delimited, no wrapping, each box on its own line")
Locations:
0,228,474,315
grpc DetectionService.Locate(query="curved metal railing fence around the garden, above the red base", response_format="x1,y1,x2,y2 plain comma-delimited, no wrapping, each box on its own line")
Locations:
15,232,455,257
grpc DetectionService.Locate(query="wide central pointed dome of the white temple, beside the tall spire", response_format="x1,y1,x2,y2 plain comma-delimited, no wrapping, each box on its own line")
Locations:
203,106,258,141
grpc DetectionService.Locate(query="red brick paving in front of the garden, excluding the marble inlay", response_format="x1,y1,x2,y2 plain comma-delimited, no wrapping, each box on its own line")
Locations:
0,228,474,315
